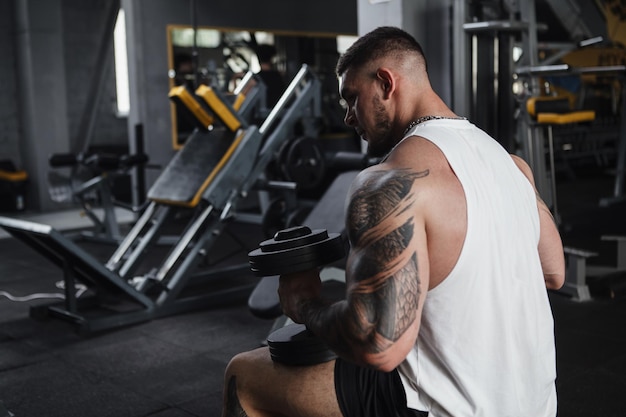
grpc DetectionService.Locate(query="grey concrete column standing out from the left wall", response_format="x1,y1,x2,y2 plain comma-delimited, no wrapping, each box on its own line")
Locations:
13,0,69,209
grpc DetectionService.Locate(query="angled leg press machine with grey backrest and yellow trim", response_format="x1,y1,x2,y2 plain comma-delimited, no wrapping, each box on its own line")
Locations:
0,65,321,333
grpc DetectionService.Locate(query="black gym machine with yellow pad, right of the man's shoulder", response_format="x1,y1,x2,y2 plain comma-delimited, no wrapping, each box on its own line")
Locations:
517,55,626,302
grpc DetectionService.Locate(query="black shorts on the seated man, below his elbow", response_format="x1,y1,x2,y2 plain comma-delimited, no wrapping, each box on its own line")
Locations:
335,359,428,417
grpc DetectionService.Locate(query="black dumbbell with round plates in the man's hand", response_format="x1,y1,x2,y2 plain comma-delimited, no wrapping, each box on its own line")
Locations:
248,226,345,365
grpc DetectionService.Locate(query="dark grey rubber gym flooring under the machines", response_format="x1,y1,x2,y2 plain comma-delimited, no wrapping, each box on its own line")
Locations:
0,167,626,417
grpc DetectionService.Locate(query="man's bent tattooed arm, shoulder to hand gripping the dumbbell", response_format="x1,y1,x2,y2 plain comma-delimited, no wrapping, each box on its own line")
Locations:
281,168,428,371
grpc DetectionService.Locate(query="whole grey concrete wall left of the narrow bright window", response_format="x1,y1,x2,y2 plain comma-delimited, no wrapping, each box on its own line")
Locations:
0,0,128,211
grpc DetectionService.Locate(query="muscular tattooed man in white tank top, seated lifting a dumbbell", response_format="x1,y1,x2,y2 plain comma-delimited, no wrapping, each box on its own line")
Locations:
224,27,564,417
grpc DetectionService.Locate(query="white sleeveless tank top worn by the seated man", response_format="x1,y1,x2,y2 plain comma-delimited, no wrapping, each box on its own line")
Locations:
398,119,556,417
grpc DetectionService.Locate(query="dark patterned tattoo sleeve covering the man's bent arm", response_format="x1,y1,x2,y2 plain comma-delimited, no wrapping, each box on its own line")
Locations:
307,170,428,357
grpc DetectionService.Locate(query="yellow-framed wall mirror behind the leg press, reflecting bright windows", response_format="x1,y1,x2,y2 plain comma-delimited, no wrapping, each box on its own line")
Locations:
167,25,354,149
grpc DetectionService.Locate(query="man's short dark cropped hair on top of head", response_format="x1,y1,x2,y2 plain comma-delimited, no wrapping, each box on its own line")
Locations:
336,26,424,76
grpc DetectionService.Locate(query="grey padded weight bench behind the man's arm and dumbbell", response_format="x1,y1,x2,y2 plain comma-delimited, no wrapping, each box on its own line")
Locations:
248,171,359,333
